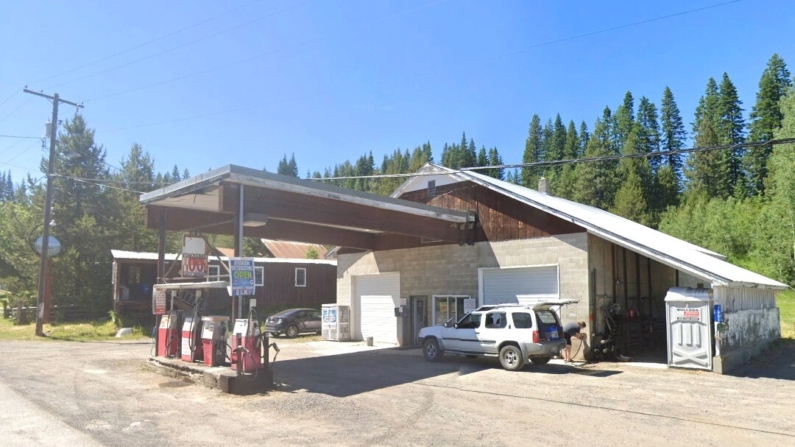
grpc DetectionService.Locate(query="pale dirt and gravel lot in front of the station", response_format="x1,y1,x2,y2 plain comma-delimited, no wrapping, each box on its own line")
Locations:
0,339,795,446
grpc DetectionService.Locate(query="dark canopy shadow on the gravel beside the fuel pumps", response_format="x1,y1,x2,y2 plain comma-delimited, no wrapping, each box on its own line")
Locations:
273,348,621,397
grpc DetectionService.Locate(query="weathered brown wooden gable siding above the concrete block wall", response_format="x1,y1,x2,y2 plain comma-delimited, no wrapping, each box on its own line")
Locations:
400,182,585,242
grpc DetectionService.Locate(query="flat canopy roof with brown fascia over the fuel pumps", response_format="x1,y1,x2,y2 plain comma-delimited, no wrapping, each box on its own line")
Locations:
140,165,472,249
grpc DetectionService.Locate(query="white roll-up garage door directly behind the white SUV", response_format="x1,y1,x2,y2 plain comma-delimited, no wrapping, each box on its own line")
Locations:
481,265,559,304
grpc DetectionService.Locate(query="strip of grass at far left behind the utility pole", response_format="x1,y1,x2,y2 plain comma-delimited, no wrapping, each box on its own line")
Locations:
0,319,148,341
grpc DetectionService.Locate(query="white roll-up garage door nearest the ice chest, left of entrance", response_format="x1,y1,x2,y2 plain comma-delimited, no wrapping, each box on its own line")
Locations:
354,272,400,344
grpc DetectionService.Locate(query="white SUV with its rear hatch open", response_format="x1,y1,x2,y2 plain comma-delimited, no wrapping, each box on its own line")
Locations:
419,300,577,371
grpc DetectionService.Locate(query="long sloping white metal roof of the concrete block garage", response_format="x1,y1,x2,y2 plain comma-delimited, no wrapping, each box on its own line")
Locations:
410,164,788,289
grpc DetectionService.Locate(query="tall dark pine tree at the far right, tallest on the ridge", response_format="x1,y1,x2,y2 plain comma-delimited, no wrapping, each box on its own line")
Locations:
745,54,792,195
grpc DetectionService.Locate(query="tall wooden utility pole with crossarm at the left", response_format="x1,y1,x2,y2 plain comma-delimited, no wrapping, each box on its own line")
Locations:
23,89,83,337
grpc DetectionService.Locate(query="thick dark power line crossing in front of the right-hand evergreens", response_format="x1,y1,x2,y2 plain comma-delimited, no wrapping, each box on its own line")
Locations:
314,138,795,181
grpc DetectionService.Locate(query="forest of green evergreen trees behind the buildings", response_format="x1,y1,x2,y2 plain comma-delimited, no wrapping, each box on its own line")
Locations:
0,55,795,314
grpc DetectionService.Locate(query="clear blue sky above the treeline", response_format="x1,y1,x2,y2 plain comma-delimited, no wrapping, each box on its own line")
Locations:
0,0,795,186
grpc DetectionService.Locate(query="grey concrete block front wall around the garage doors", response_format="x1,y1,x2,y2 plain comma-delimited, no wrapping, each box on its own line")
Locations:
337,233,589,344
